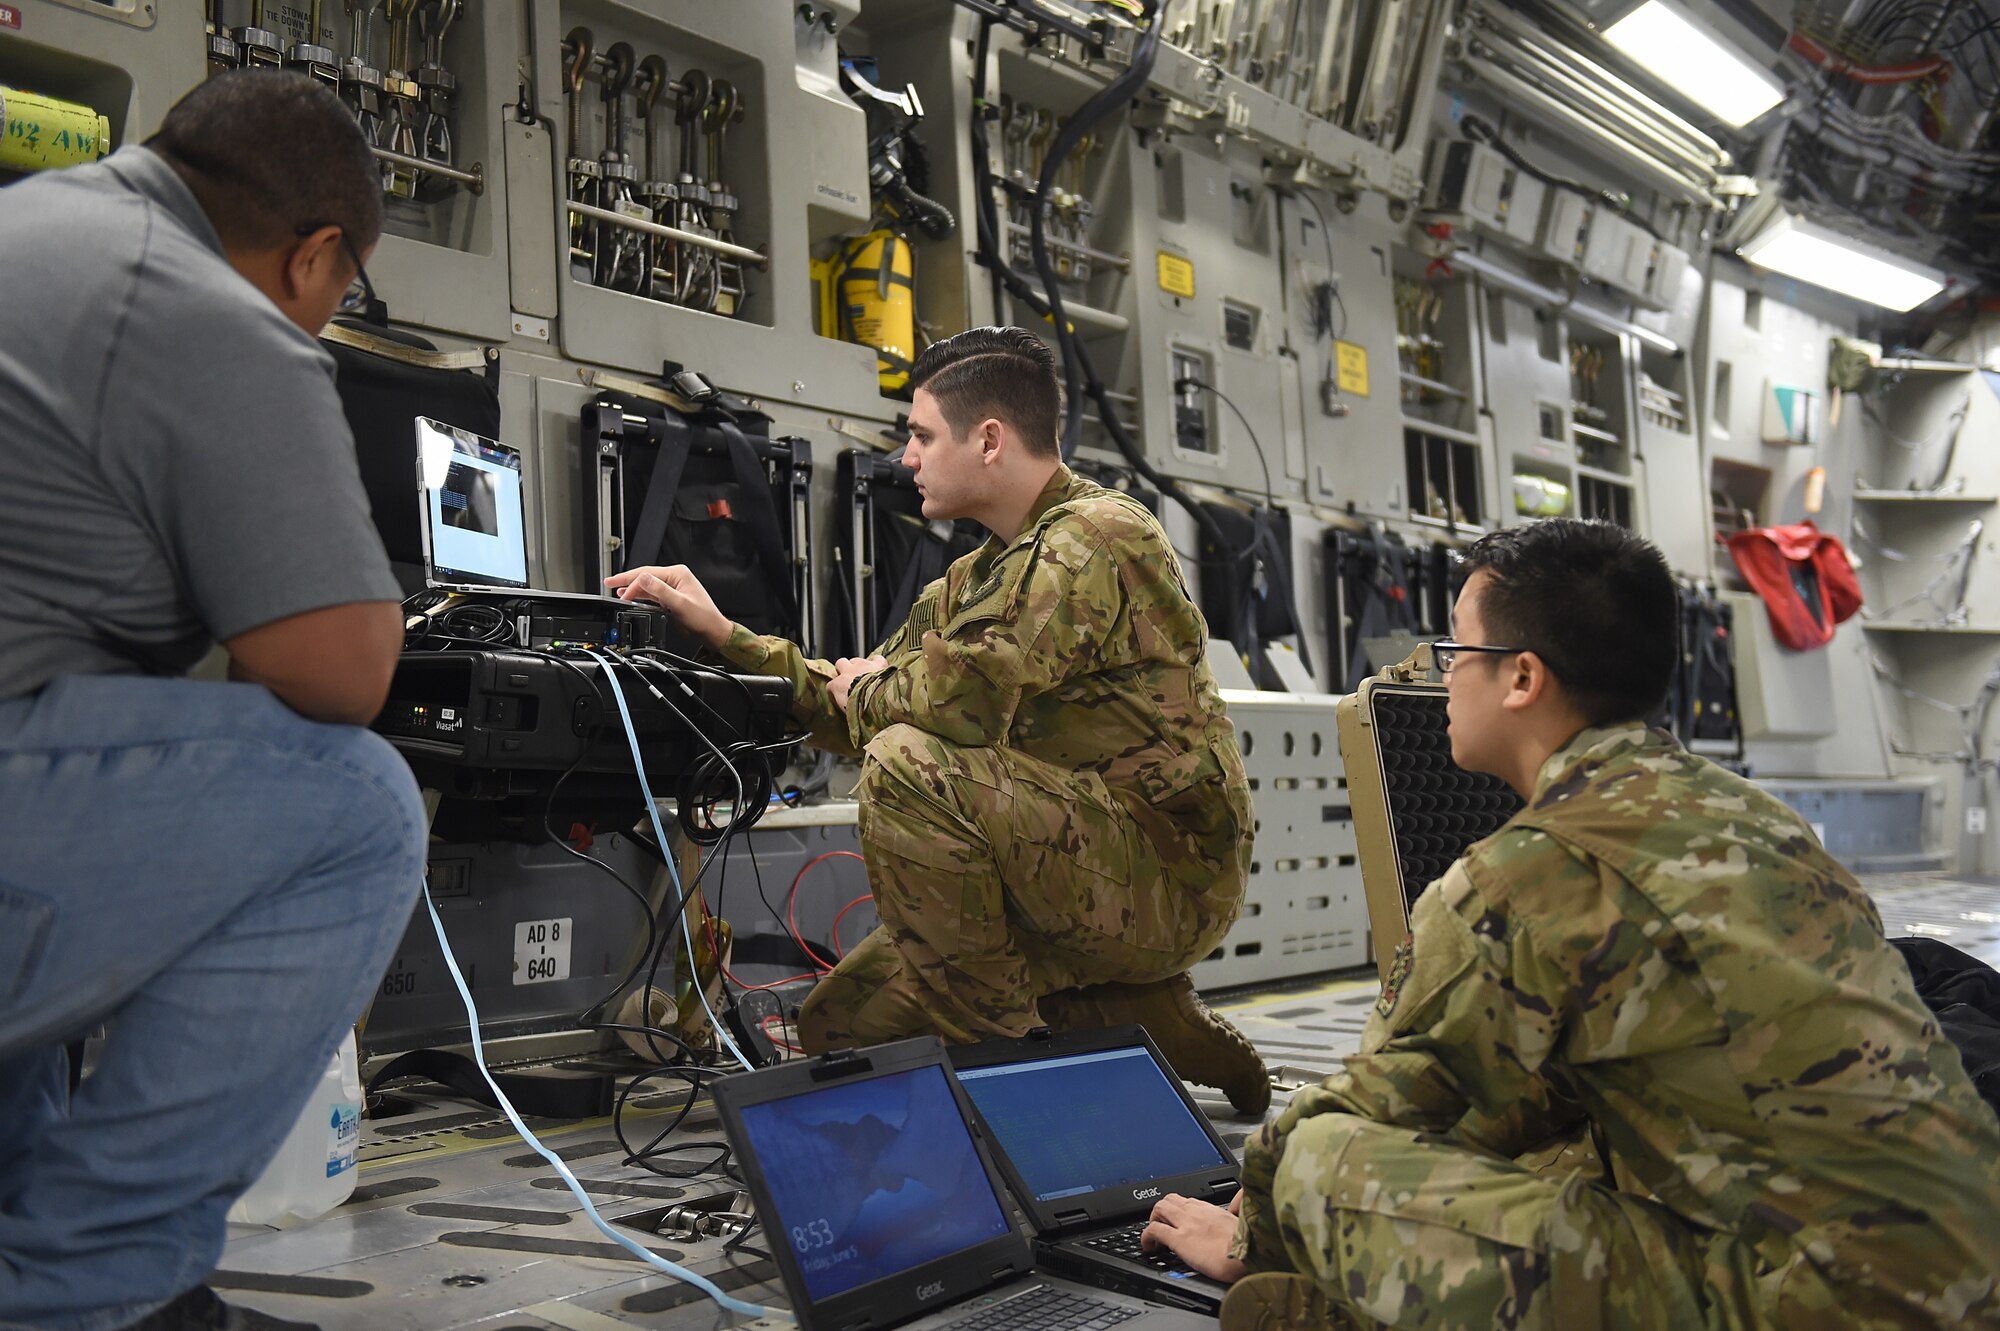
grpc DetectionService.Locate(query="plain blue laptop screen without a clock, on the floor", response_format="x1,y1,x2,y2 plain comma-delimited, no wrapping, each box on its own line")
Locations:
958,1045,1236,1201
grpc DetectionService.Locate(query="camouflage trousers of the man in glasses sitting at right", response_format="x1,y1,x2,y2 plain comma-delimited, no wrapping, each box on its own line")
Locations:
1222,1113,1904,1331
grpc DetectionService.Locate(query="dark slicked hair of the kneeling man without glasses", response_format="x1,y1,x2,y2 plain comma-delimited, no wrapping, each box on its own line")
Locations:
910,328,1062,458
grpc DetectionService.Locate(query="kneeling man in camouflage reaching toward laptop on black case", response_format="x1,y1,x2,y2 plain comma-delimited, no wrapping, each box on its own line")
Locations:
608,328,1270,1113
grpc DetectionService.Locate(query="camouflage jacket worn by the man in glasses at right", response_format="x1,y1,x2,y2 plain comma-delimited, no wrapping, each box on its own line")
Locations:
1236,723,2000,1325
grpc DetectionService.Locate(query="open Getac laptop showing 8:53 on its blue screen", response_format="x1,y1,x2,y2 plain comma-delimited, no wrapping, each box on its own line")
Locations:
714,1037,1216,1331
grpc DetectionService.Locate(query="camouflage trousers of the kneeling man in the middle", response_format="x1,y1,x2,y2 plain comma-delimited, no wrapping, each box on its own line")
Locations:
800,725,1234,1053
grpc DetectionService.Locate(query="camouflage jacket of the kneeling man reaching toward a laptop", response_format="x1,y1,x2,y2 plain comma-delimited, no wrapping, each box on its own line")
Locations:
724,468,1250,897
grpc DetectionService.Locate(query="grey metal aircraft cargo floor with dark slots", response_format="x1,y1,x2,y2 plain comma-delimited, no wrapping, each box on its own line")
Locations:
212,873,2000,1331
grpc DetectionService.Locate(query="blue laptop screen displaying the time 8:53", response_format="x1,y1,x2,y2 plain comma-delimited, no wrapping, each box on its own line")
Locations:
742,1065,1012,1303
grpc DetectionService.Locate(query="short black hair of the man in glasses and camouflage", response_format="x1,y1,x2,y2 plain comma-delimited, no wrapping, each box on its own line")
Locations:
1466,518,1680,725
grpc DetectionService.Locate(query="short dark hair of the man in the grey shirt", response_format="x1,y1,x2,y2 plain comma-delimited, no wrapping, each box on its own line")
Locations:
146,70,382,254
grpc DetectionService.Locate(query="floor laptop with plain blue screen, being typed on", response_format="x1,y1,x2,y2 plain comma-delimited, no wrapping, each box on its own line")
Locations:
950,1025,1238,1313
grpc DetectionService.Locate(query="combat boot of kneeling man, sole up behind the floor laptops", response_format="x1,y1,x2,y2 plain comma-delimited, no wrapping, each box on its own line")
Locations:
1038,973,1270,1117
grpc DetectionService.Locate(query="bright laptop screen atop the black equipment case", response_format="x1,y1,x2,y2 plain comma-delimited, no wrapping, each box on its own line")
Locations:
416,416,528,588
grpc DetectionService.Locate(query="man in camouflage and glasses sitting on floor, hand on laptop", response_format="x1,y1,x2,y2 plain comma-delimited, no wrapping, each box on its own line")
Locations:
1146,520,2000,1331
